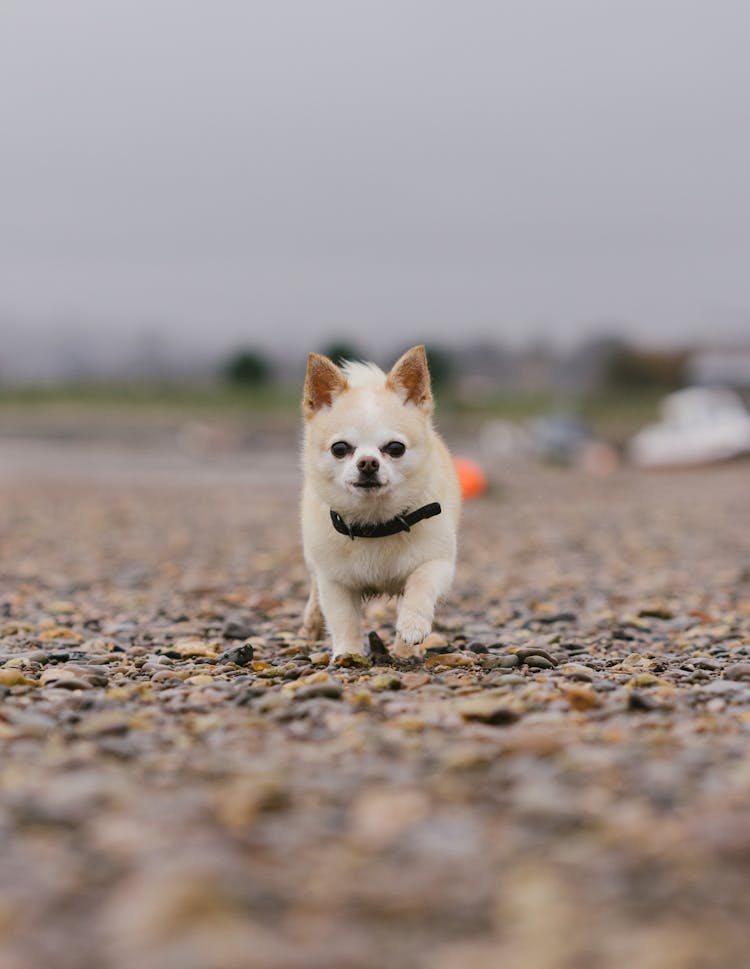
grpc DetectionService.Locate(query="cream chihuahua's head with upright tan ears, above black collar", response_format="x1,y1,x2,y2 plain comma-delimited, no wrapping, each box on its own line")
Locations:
302,346,434,517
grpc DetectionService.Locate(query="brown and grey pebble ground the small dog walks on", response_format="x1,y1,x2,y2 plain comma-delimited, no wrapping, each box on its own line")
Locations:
0,454,750,969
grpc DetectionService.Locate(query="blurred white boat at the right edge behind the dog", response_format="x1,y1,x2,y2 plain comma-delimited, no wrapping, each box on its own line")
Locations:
628,387,750,468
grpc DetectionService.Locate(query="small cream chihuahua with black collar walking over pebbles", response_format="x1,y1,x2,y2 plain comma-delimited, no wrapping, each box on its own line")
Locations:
301,346,461,659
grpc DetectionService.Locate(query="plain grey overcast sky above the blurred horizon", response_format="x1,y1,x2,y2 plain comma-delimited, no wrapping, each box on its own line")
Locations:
0,0,750,360
